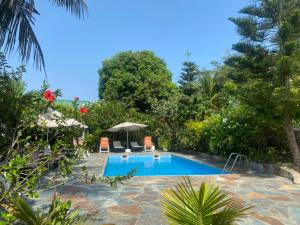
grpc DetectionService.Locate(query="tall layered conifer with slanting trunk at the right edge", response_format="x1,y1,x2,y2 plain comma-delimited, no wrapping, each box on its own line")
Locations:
226,0,300,170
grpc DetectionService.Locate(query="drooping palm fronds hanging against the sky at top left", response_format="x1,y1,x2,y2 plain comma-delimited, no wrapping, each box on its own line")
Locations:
0,0,87,69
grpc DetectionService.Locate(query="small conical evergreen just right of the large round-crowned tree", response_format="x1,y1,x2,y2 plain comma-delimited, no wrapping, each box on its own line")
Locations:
178,52,200,96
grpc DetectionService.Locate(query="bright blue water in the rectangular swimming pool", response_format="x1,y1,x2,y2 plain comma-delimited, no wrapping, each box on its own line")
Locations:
104,154,222,176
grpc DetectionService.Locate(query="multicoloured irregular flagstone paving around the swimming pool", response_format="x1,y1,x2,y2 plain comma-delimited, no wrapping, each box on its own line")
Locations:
34,154,300,225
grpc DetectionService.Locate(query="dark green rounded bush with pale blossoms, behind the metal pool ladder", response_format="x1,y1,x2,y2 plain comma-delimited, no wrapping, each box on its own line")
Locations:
209,106,287,163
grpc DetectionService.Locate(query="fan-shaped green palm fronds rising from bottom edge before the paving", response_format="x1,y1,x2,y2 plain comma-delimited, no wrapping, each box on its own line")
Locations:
162,178,252,225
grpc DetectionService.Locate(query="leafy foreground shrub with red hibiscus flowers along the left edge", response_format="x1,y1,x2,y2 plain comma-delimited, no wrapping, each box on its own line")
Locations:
0,57,134,225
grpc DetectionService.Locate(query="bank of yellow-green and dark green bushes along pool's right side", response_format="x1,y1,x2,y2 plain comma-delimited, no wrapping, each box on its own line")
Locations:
179,105,289,163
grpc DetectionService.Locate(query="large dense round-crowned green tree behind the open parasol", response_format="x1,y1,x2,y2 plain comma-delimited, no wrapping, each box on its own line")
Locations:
98,51,175,112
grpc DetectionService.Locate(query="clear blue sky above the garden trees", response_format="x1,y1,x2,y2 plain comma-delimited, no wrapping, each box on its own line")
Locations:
9,0,249,100
